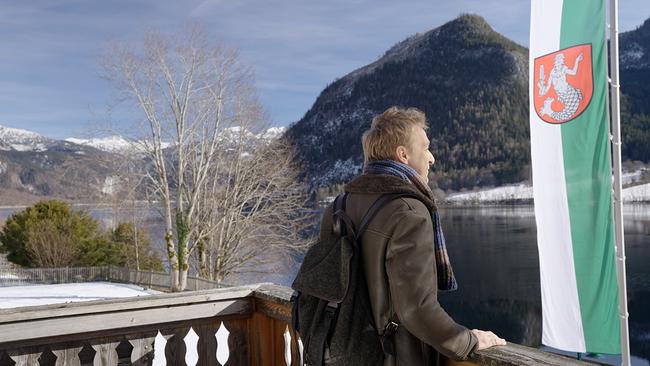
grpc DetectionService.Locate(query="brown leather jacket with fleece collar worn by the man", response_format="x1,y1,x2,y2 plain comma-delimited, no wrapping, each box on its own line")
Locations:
321,175,477,366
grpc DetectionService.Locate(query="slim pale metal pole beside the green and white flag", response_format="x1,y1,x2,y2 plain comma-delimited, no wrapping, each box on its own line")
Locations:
609,0,630,366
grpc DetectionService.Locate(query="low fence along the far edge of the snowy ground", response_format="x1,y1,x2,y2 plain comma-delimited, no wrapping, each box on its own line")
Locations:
0,266,226,290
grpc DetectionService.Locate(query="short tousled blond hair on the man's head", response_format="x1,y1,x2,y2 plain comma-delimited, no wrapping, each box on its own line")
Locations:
361,107,429,162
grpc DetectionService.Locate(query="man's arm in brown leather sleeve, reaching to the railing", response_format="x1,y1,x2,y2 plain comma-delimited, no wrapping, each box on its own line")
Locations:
386,202,477,359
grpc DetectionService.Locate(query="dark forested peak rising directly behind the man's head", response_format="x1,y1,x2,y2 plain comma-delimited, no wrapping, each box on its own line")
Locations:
286,15,530,189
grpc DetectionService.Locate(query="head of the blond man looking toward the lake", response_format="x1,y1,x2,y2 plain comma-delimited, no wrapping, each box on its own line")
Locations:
362,107,435,182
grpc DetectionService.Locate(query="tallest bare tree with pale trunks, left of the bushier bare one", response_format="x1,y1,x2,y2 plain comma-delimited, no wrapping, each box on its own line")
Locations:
104,27,308,291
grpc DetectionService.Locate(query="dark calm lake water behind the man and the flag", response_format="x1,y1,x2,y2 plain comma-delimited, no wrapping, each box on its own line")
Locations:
0,205,650,366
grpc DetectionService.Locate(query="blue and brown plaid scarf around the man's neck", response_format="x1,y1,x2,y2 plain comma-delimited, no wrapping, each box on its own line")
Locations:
363,160,458,291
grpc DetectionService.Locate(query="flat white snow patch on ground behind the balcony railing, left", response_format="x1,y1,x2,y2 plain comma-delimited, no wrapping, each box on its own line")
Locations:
0,282,160,309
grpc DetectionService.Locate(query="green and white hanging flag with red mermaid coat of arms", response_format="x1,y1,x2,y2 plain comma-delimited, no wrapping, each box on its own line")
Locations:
529,0,620,354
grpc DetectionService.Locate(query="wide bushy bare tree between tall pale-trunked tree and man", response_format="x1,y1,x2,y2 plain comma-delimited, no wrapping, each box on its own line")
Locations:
191,139,313,281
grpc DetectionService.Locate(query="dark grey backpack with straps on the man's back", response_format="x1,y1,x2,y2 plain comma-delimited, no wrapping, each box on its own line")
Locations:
291,193,417,366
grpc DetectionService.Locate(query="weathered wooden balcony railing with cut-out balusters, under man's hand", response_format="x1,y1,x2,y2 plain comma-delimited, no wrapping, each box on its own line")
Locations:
0,284,587,365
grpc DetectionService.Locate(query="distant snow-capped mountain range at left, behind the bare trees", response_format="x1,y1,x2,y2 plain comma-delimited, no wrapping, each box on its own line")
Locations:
0,126,285,205
